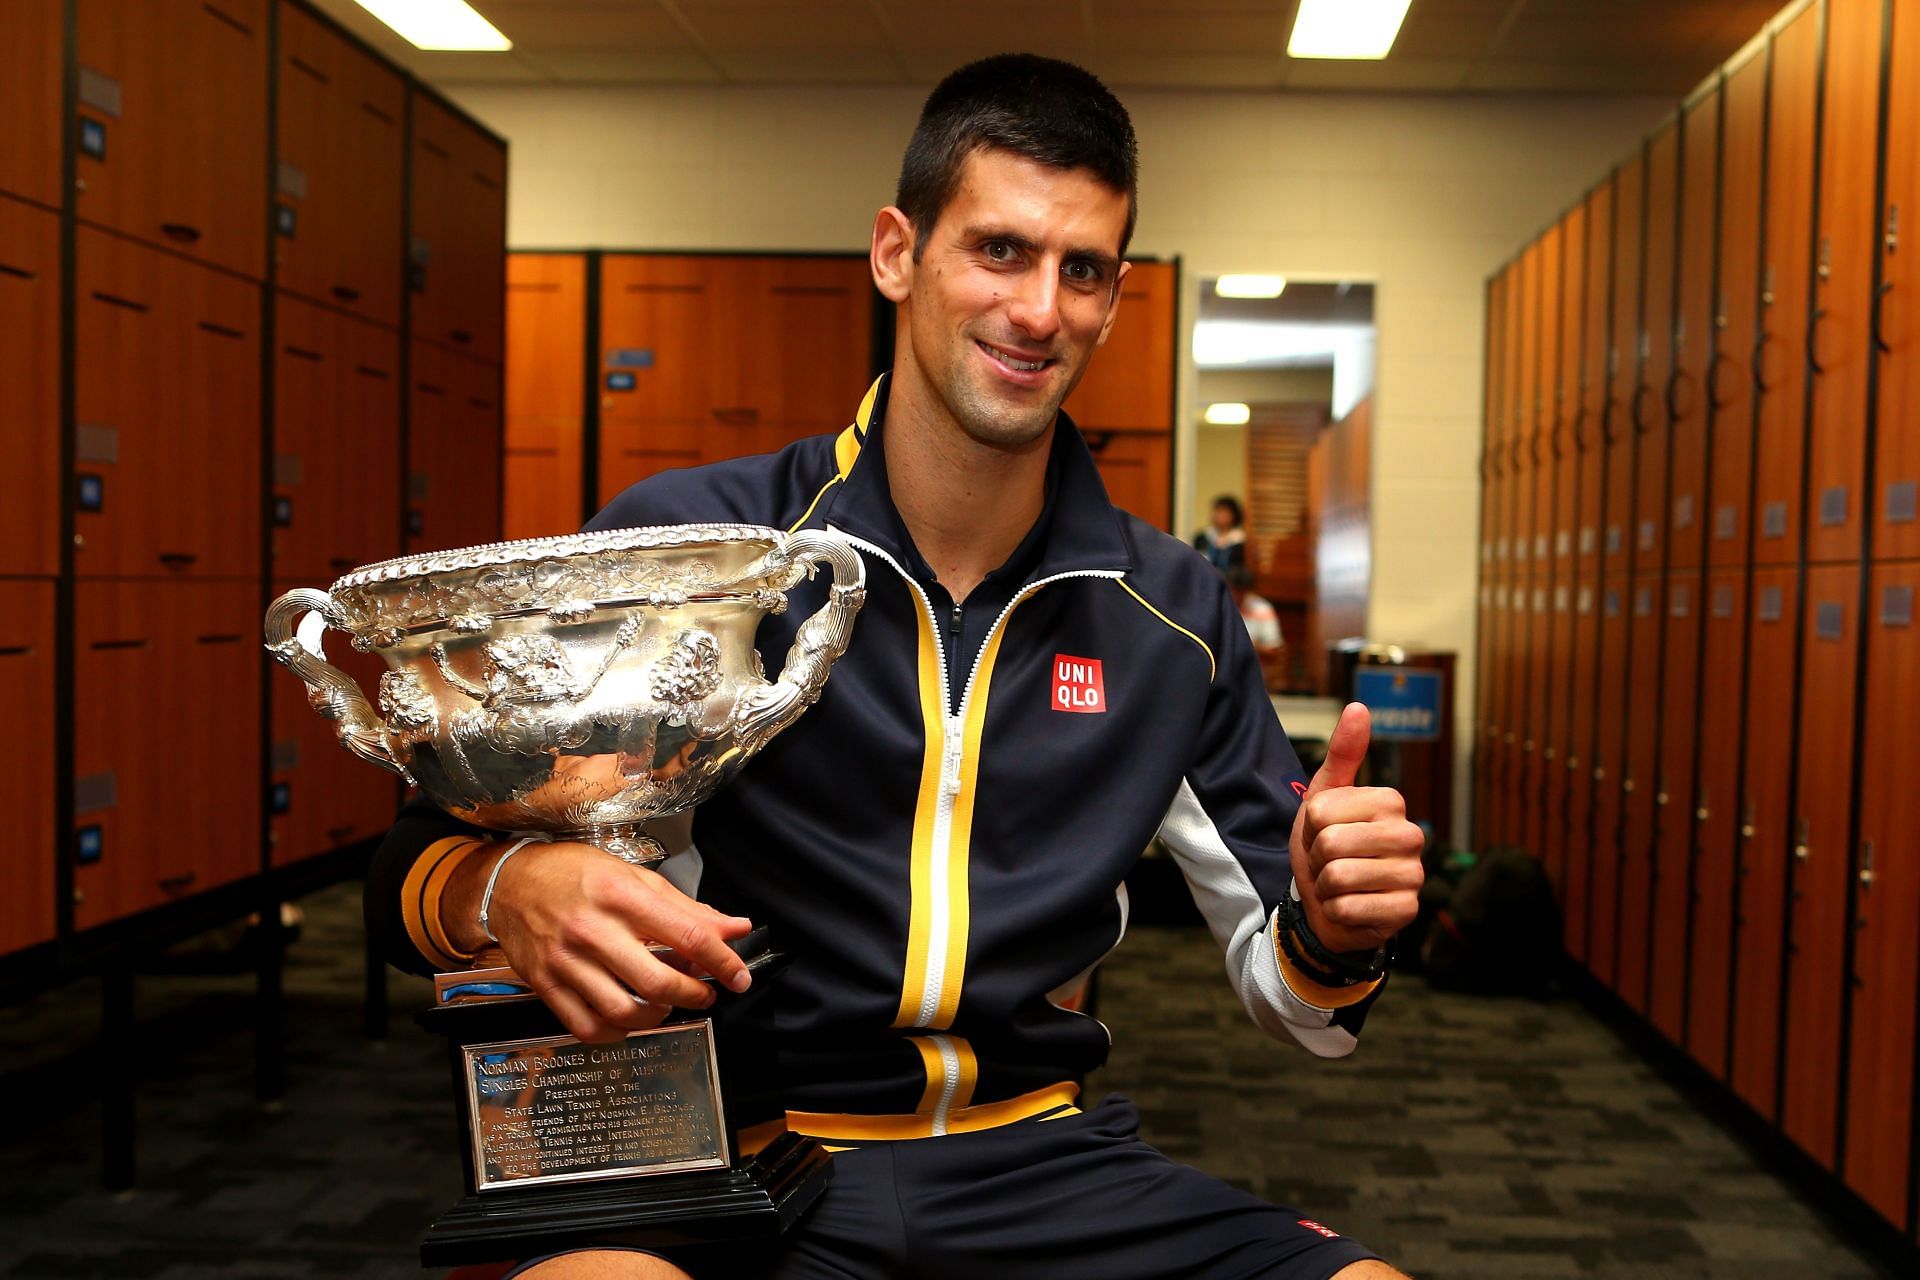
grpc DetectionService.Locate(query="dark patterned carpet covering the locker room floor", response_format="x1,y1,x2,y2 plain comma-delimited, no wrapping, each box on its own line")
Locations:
0,887,1887,1280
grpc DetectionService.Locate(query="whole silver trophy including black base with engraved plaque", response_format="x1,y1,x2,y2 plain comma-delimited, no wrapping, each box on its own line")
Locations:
267,524,866,1267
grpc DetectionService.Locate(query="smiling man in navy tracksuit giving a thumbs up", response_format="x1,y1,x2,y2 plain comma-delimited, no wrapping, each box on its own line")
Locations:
369,56,1421,1280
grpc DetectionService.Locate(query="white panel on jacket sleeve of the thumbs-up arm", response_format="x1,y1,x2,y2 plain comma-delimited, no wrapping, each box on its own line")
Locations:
1160,779,1357,1057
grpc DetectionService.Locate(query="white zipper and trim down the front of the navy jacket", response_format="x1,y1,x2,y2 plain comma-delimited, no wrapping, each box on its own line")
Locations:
828,526,1125,1136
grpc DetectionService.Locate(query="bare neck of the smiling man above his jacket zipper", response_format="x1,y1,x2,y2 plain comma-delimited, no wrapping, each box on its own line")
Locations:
885,368,1054,603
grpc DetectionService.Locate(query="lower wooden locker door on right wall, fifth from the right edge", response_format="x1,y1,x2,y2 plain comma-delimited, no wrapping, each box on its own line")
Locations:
1647,572,1704,1044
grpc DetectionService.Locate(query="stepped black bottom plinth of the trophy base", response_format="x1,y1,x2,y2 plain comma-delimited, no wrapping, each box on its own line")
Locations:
420,1132,833,1267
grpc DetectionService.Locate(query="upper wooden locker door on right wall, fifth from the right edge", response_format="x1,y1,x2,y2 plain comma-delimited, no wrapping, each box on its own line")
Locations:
1663,88,1720,575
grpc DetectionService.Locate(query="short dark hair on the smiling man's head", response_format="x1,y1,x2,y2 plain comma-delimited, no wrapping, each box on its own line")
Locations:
893,54,1140,257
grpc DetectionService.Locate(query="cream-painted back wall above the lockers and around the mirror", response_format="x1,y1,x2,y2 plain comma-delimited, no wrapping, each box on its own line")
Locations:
447,84,1672,831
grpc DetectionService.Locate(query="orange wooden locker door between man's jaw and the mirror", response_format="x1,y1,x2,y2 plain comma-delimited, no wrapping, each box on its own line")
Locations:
1067,259,1179,435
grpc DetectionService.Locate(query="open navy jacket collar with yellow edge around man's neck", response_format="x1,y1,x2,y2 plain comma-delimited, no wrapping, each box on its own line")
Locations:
816,374,1133,578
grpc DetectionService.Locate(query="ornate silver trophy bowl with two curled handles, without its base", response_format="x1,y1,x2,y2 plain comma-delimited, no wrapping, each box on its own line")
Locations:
267,524,866,864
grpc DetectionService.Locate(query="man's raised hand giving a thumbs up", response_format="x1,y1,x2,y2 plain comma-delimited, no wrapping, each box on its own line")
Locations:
1290,702,1427,952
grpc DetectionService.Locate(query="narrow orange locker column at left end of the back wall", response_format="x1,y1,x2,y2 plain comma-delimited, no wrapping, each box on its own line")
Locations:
503,253,588,537
